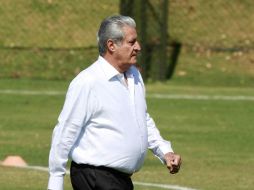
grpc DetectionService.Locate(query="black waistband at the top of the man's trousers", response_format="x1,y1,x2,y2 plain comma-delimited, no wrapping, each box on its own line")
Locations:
71,161,132,178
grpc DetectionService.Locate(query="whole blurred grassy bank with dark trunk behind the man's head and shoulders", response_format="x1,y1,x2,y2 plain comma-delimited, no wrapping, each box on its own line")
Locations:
0,0,254,86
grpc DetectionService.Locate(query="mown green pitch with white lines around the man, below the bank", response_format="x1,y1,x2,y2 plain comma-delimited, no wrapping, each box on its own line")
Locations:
0,79,254,190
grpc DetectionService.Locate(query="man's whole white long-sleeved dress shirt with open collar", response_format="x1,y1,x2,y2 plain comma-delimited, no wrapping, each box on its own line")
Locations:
48,56,173,190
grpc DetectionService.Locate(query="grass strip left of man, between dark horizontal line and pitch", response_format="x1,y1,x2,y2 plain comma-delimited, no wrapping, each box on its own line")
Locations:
0,48,98,80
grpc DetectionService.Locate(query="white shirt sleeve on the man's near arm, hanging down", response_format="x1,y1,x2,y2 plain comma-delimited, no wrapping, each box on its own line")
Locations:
48,77,93,190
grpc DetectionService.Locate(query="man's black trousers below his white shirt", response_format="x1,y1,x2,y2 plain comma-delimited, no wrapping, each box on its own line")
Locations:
71,162,133,190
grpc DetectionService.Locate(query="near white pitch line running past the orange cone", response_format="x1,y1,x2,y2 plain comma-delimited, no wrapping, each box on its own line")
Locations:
0,162,197,190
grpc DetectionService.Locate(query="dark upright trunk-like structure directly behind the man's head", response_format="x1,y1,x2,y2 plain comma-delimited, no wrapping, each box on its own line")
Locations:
120,0,181,80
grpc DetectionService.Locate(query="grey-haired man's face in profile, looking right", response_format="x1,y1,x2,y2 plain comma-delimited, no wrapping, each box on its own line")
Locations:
115,26,141,70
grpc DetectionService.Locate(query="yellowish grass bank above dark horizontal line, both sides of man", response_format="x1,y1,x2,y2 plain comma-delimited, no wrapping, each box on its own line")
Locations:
0,0,254,47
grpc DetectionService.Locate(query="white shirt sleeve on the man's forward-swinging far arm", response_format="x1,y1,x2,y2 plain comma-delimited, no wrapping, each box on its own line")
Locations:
146,113,173,164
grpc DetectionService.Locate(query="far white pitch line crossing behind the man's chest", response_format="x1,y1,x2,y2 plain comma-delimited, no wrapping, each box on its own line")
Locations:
0,89,254,101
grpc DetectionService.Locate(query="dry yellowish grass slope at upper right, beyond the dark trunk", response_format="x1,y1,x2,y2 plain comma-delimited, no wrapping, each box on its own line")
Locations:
168,0,254,47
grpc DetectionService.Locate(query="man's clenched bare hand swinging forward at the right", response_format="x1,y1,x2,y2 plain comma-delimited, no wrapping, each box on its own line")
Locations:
164,152,181,174
